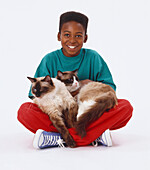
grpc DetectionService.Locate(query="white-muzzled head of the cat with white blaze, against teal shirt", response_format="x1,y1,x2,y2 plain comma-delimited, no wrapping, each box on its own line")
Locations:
56,70,80,92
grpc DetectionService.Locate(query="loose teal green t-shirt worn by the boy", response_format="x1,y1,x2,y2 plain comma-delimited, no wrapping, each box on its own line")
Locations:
29,48,116,96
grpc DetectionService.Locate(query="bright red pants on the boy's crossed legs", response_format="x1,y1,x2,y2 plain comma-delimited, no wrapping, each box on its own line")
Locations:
18,99,133,146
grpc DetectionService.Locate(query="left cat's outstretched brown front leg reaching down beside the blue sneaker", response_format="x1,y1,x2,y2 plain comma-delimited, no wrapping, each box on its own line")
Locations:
49,111,76,148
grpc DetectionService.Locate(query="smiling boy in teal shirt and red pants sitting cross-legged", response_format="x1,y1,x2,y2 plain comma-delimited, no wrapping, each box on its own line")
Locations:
18,12,133,148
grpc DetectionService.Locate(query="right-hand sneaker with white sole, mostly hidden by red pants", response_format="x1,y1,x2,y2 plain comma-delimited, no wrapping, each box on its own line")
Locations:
92,129,112,146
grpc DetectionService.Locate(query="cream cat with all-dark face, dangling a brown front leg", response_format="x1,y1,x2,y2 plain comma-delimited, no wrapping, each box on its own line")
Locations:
28,76,78,147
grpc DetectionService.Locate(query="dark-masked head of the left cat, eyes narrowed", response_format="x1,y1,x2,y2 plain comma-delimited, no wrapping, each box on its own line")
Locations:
27,75,55,98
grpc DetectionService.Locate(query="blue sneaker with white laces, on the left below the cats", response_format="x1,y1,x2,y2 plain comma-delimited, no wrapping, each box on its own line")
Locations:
33,129,65,149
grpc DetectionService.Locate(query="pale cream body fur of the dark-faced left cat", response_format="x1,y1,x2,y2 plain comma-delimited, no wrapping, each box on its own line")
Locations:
33,78,76,116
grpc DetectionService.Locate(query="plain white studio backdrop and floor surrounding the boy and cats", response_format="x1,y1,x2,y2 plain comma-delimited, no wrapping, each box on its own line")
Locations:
0,0,150,170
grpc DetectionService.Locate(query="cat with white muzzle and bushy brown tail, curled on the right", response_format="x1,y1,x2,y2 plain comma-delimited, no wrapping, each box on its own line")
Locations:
56,70,118,138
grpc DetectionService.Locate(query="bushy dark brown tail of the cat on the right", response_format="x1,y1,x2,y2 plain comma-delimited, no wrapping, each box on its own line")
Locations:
75,91,118,138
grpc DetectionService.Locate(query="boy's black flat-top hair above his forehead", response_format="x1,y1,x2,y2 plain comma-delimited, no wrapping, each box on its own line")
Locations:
59,11,88,34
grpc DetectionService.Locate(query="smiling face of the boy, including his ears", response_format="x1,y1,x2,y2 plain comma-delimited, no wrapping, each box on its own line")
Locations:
58,21,87,57
